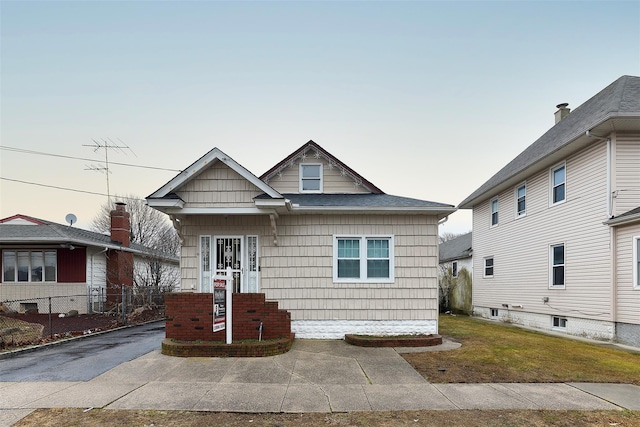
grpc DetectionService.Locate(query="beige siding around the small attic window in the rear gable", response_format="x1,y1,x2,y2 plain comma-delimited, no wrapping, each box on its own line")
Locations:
269,159,369,194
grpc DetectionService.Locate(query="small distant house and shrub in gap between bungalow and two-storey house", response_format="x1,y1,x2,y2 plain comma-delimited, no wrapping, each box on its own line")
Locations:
438,232,473,314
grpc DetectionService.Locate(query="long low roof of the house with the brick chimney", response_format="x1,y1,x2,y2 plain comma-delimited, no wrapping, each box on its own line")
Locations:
0,214,179,263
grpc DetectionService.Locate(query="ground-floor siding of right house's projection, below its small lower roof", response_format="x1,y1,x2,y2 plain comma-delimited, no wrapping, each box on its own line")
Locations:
615,223,640,325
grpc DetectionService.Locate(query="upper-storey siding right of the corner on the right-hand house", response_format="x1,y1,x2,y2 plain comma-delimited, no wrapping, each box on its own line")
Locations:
612,134,640,216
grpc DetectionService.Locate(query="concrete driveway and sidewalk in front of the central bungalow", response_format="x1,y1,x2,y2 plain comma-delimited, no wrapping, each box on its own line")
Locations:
0,340,640,425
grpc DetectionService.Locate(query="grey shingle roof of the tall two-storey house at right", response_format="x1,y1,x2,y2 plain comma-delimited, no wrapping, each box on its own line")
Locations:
458,76,640,209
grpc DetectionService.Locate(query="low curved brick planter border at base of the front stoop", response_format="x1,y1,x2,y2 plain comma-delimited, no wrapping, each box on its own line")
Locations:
162,334,294,357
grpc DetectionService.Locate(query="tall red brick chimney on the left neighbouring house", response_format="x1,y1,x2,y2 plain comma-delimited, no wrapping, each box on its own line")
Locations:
107,202,133,306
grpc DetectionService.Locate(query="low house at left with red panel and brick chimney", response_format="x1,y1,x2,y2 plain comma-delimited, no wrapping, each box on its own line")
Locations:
0,204,178,314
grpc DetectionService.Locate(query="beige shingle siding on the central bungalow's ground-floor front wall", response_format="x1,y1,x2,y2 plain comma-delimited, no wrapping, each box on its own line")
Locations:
182,215,438,320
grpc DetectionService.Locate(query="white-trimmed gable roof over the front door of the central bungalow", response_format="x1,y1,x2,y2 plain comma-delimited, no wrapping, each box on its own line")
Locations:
147,147,282,200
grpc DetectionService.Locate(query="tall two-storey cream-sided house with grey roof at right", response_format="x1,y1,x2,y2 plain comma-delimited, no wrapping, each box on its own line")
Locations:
459,76,640,346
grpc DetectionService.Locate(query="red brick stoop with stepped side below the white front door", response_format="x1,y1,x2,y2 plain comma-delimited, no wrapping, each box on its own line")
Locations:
162,292,293,356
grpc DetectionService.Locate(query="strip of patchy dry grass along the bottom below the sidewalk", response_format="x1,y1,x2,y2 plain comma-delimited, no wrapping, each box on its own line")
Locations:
14,409,640,427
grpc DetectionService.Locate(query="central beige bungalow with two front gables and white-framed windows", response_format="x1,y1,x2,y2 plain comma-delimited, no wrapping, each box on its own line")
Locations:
147,141,455,338
